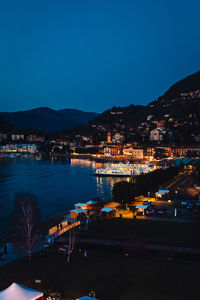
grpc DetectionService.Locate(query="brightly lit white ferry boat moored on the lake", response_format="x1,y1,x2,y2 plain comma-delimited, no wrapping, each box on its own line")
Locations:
95,163,155,177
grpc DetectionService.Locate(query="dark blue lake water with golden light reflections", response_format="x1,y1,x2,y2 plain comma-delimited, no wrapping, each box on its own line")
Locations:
0,158,126,231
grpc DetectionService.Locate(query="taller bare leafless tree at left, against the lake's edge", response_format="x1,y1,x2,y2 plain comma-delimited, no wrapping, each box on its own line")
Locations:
13,193,39,260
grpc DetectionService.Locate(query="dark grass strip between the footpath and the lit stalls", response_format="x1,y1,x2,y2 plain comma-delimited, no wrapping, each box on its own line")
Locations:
82,218,200,247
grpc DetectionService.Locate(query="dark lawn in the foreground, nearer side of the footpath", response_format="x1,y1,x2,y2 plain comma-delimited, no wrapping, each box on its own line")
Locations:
0,246,200,300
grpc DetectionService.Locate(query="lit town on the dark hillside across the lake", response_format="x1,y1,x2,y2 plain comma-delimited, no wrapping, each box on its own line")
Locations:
0,81,200,161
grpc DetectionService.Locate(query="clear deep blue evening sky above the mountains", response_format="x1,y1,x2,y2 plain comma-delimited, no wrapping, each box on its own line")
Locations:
0,0,200,112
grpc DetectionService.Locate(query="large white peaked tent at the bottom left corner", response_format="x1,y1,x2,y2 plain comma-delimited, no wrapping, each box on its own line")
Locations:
0,283,43,300
